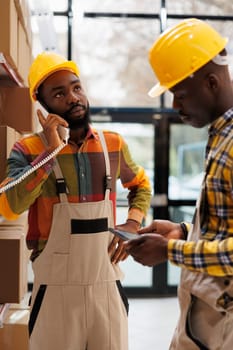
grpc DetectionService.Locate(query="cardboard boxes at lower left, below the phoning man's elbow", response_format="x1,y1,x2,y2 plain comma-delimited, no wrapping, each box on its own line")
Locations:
0,212,29,350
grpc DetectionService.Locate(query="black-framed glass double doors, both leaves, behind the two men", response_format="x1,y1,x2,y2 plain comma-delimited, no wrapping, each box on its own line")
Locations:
93,109,207,297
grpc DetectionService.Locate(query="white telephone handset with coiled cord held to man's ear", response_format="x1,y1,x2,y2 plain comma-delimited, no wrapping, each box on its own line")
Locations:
0,106,69,193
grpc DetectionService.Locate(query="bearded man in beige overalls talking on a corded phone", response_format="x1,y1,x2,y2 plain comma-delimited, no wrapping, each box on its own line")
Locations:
0,53,151,350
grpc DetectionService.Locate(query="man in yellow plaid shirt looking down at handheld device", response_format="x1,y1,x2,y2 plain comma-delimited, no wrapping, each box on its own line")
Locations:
126,18,233,350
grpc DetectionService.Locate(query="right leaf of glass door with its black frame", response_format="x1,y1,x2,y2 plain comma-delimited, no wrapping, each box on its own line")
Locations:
153,113,207,294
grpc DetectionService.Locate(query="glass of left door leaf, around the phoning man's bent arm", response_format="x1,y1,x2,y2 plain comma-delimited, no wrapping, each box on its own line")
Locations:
93,123,154,287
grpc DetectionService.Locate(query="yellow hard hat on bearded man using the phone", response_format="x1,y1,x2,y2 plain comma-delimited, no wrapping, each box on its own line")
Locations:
28,52,79,101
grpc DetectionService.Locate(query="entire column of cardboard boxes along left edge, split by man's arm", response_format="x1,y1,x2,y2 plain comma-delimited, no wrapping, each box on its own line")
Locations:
0,0,35,350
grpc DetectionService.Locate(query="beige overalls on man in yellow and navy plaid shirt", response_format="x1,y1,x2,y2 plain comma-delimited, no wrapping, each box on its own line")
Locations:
170,135,233,350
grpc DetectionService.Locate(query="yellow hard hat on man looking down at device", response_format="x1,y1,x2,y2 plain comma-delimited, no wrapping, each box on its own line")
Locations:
149,18,228,97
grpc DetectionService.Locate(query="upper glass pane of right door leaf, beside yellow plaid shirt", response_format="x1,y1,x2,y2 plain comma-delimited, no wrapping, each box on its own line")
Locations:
169,124,207,199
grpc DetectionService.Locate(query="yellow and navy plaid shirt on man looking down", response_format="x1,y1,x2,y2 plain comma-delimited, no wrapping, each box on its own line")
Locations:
168,108,233,276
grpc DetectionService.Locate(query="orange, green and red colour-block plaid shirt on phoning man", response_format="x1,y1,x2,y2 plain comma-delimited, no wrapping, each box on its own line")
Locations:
0,127,151,258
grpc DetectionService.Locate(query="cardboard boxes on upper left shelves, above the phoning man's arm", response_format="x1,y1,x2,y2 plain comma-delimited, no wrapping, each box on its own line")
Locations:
0,0,35,181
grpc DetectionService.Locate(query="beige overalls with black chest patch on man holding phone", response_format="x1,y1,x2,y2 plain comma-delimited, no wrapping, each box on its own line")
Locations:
29,133,128,350
